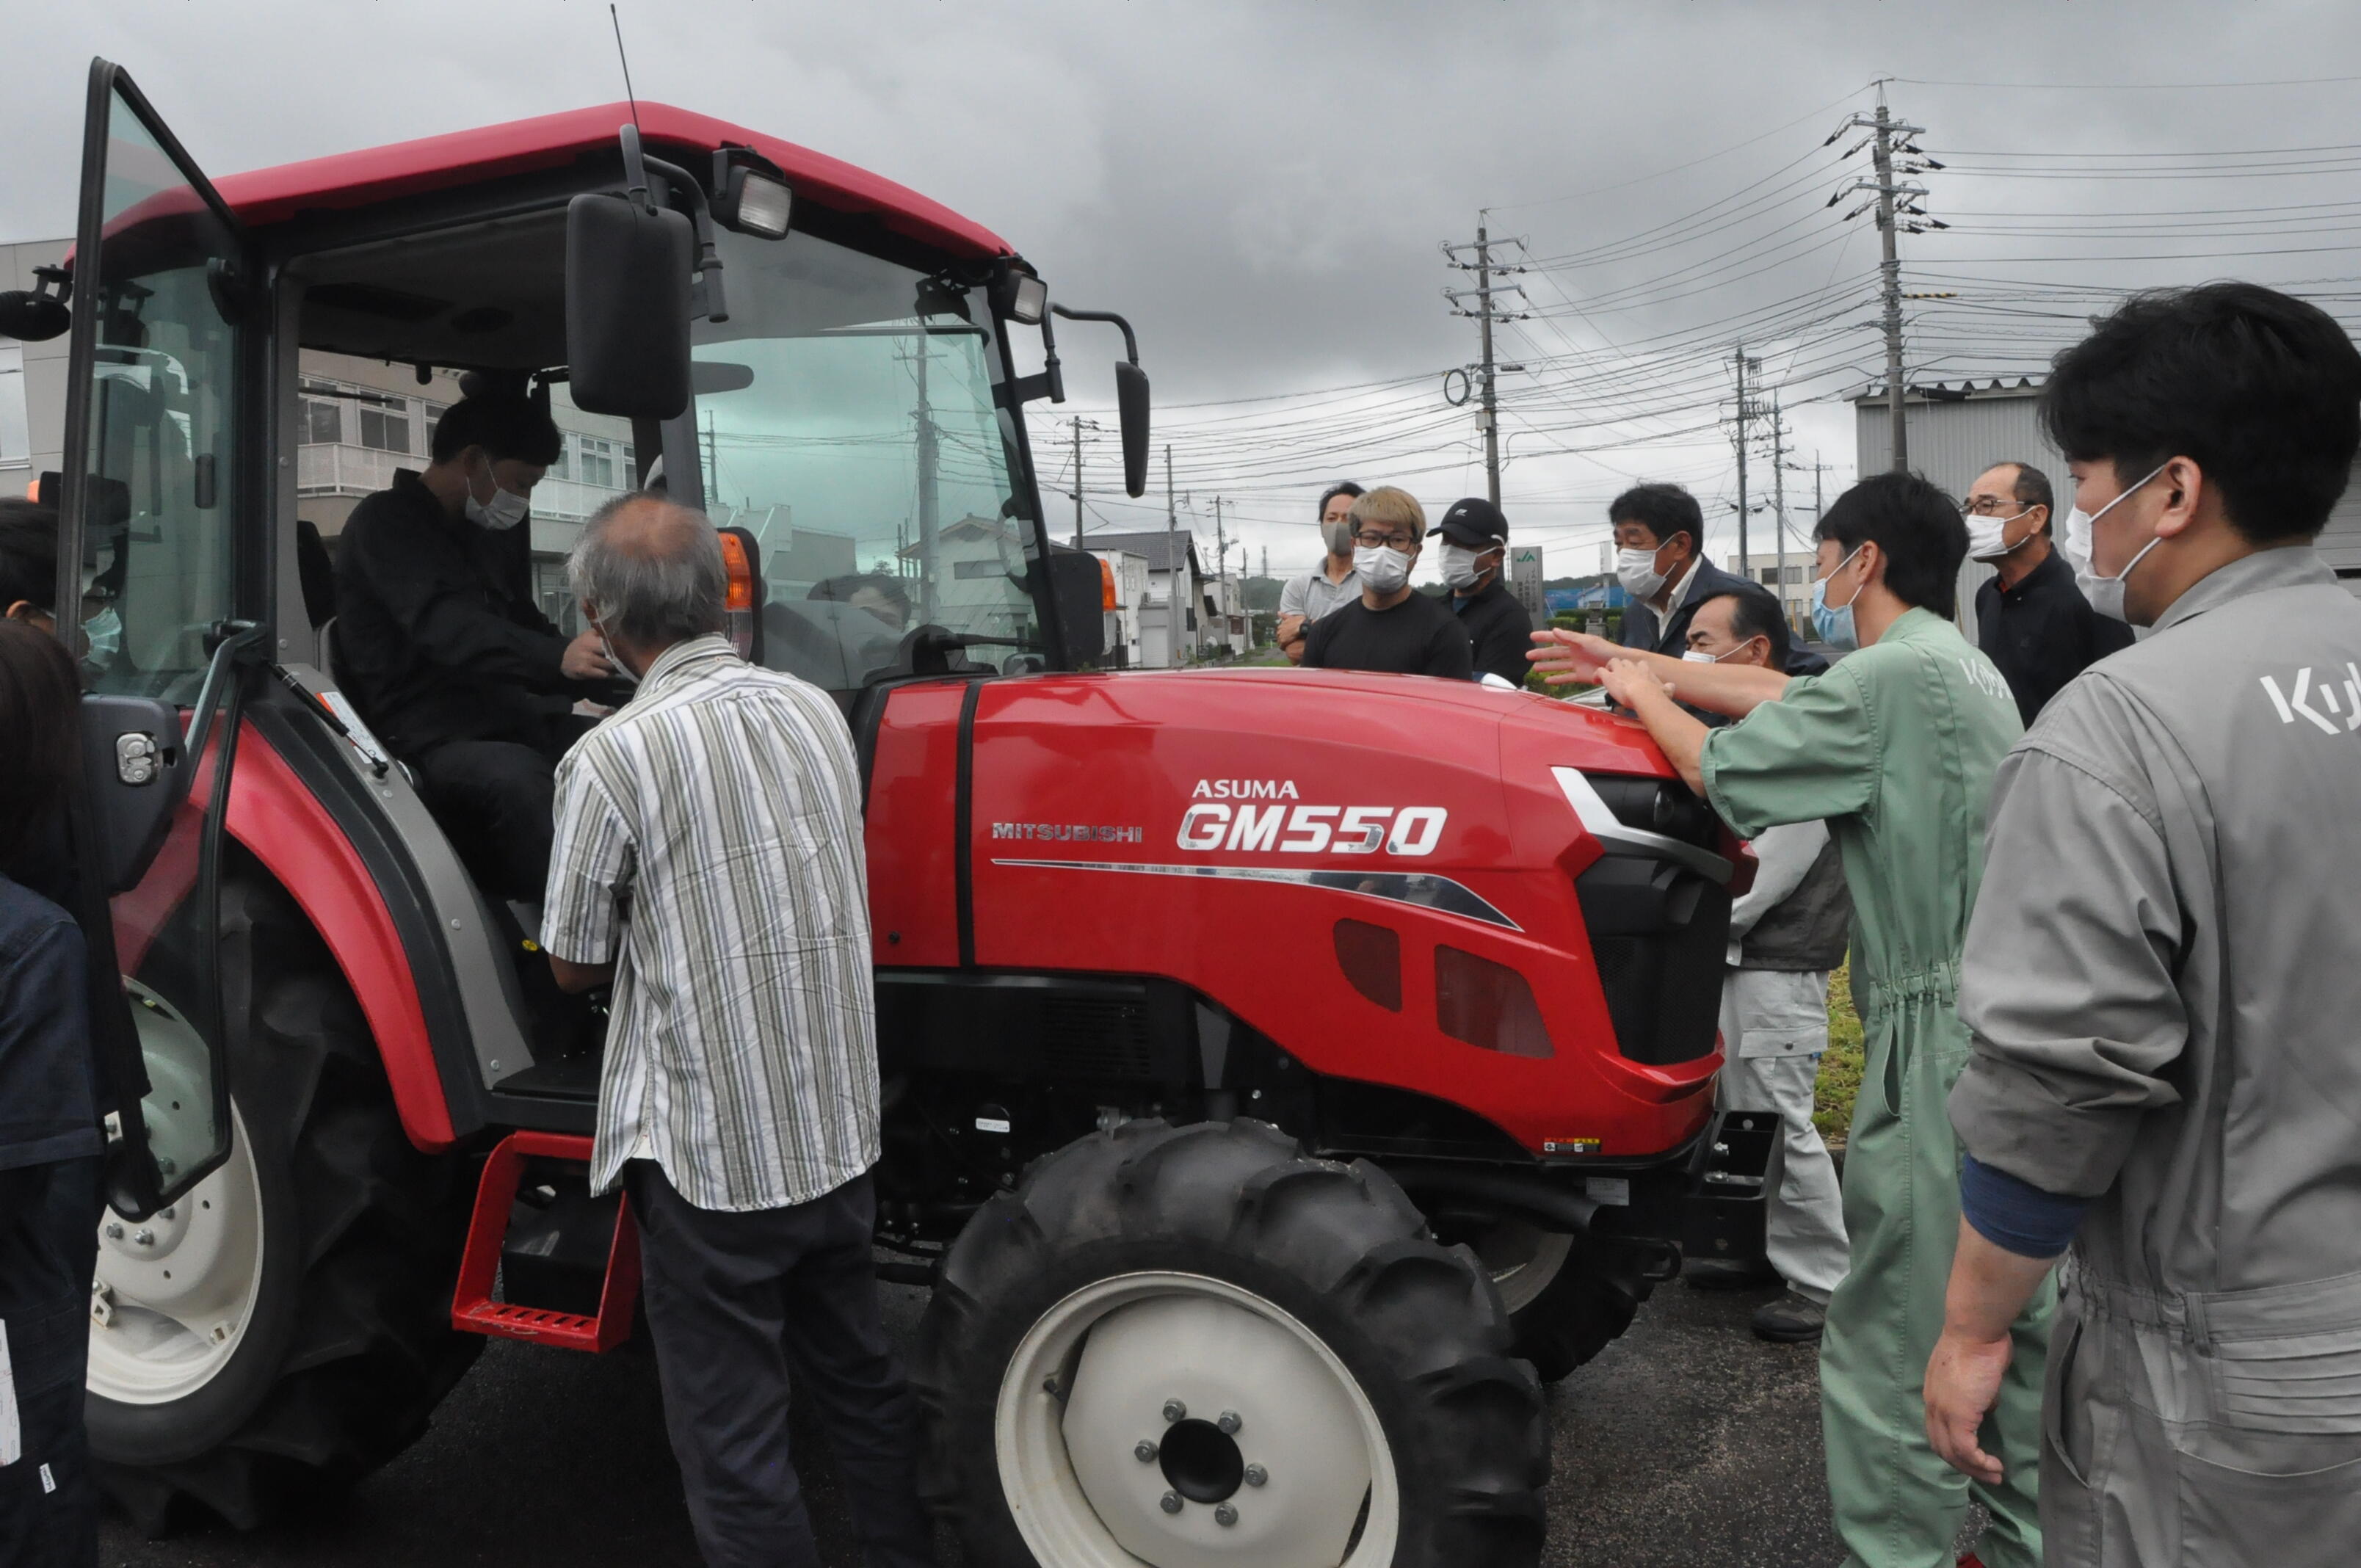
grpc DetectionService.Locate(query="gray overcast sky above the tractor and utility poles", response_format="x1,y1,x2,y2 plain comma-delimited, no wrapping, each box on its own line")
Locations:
13,0,2361,576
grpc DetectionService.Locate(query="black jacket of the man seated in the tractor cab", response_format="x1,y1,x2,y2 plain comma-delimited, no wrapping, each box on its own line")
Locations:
336,470,592,755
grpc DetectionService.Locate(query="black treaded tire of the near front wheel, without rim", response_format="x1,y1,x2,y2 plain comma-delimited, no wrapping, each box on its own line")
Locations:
911,1119,1549,1568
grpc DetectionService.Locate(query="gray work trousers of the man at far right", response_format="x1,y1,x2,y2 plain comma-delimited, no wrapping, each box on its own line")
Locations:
2040,1266,2361,1568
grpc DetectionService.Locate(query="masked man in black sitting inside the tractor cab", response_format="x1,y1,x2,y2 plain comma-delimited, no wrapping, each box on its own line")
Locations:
333,396,614,902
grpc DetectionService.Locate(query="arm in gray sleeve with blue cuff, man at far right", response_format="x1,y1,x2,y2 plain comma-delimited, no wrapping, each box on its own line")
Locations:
1926,713,2188,1481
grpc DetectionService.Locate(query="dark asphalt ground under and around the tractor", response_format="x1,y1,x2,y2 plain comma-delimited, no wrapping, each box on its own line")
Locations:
99,1285,1841,1568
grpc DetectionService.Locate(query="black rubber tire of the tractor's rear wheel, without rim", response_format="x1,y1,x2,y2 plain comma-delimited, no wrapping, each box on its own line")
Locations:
87,881,484,1535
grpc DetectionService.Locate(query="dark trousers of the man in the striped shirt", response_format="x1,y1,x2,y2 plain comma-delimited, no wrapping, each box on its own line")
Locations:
623,1159,935,1568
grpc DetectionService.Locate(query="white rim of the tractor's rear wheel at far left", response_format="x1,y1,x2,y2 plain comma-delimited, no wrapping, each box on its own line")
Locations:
87,1001,262,1405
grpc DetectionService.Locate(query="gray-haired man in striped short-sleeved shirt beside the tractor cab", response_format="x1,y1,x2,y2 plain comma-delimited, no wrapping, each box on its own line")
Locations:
540,496,932,1568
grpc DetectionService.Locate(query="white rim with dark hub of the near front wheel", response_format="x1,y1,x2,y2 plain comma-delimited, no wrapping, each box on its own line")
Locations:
994,1273,1400,1568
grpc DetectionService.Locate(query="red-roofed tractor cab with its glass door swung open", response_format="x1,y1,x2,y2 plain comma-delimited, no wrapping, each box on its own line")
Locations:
0,62,1147,1213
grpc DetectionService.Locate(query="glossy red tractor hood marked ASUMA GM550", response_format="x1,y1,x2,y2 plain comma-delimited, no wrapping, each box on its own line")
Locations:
868,671,1738,1153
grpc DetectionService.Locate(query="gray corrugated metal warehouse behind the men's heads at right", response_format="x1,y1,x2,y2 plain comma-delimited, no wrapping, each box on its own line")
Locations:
1854,378,2361,638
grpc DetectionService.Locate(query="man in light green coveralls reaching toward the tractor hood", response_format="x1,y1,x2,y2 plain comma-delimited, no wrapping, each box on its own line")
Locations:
1532,475,2052,1568
